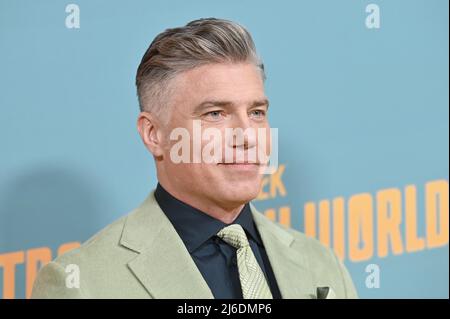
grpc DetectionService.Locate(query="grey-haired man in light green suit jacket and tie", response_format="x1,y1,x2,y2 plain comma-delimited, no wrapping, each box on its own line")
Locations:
33,18,356,299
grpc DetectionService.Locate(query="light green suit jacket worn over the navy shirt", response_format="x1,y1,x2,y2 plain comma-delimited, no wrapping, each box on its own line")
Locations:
32,192,357,299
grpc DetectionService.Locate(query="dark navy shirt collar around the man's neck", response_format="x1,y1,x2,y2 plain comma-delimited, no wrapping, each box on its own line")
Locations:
155,183,262,253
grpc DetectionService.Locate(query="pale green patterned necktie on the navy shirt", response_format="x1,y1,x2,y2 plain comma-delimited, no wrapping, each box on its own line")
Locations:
217,224,272,299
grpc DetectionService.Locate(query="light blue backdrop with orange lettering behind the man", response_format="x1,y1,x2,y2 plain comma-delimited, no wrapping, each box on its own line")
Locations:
0,0,449,298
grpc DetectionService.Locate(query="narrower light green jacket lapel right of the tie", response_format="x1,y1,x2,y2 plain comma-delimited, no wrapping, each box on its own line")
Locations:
251,205,315,299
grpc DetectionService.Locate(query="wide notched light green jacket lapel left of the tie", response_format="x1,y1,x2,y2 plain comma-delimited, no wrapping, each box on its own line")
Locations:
120,192,213,299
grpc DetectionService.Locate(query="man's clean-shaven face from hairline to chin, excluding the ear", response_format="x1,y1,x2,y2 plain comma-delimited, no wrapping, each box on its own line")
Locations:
158,63,269,207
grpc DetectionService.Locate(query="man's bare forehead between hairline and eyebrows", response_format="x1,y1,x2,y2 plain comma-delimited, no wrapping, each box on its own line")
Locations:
173,63,265,106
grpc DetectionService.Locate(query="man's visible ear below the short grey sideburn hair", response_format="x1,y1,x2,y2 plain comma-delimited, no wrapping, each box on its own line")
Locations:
137,112,164,158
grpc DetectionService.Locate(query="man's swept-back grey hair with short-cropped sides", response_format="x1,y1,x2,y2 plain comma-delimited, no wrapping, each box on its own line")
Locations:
136,18,266,117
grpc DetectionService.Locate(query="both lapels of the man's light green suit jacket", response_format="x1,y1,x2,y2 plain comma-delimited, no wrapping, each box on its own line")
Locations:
120,192,312,299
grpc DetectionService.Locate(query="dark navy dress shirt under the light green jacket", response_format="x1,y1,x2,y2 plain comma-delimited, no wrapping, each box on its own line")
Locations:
155,183,281,299
